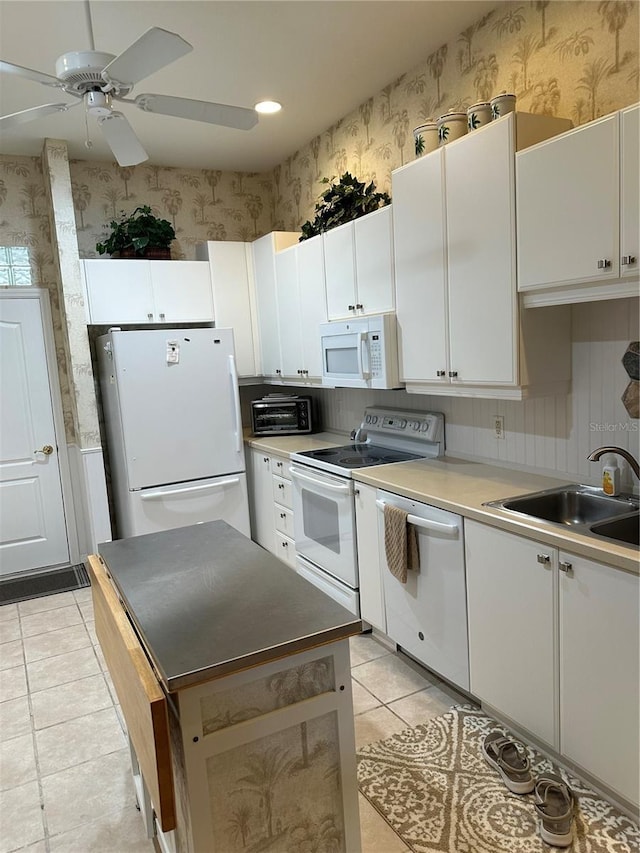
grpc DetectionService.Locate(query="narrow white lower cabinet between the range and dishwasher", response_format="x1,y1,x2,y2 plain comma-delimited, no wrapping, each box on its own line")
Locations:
355,483,387,633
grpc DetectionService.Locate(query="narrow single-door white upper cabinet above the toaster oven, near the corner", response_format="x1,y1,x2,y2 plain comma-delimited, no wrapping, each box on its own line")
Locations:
251,231,299,380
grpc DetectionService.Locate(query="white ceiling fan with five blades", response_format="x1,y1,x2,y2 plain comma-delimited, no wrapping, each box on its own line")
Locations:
0,0,258,166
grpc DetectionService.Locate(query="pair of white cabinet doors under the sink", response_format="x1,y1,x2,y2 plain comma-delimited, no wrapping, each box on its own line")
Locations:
465,521,640,806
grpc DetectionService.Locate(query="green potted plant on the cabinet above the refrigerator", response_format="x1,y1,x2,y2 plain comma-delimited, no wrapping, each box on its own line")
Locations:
96,205,176,259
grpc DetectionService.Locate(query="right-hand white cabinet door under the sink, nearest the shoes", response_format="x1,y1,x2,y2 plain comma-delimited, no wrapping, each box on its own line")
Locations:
559,552,640,804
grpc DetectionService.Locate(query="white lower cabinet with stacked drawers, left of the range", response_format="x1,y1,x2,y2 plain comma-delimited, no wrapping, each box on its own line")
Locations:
247,448,296,567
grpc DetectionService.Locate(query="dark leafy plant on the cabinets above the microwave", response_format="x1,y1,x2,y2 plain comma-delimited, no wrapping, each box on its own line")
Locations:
300,172,391,240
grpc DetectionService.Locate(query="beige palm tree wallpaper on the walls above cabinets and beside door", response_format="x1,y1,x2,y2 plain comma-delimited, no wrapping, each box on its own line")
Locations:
0,0,640,446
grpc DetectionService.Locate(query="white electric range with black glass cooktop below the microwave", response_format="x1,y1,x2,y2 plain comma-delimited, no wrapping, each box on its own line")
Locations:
289,407,444,615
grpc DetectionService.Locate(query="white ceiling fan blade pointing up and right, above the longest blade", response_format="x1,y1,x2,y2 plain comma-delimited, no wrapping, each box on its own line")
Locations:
102,27,193,87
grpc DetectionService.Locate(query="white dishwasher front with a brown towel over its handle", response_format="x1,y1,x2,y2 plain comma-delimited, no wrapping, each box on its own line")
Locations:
376,489,469,691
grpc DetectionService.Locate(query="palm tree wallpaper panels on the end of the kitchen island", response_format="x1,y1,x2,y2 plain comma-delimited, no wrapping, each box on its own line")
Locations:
200,656,344,853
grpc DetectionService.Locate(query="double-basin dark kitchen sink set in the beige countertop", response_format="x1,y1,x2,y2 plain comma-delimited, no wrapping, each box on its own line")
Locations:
484,484,640,546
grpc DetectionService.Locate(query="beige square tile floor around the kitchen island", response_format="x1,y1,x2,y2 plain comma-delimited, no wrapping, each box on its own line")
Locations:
0,589,464,853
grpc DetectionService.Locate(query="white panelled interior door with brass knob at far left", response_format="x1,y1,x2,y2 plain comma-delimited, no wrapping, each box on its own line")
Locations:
0,297,69,575
